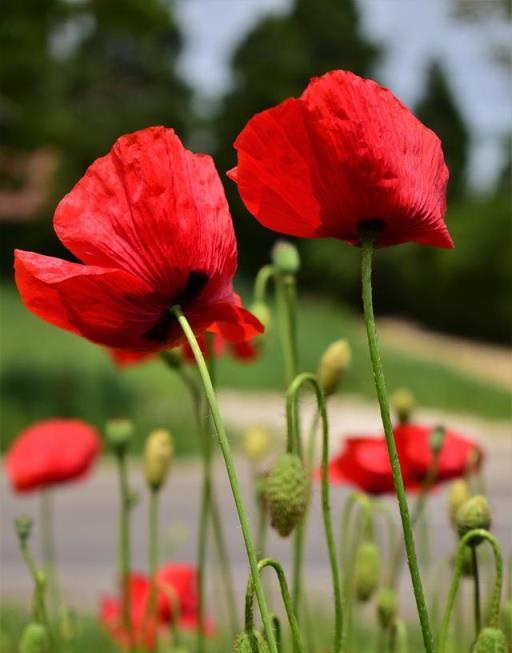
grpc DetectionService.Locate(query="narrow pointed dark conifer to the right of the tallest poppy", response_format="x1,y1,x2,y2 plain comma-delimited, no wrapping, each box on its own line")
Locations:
415,61,470,199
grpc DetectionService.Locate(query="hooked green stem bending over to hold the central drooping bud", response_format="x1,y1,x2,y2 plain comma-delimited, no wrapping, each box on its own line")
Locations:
286,372,343,653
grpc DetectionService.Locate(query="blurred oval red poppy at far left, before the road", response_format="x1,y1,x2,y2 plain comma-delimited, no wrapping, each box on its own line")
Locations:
5,419,101,492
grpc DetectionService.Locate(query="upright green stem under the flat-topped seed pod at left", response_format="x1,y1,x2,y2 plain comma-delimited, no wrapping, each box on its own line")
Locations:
116,450,133,651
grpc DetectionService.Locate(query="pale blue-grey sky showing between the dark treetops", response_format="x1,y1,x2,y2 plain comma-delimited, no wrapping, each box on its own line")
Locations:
176,0,512,190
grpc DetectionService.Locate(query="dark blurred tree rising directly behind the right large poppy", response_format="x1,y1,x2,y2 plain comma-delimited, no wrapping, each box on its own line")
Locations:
215,0,380,269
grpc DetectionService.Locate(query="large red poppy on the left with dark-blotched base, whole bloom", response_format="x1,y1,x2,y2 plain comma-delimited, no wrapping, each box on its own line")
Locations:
15,127,262,352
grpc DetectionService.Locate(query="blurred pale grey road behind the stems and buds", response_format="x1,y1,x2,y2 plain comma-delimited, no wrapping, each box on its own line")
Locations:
0,392,512,610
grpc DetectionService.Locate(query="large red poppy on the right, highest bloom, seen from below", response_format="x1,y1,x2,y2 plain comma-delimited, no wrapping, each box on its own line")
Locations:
228,70,453,247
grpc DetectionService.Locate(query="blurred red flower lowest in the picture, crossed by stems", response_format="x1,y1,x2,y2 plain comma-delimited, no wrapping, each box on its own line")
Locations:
100,563,213,648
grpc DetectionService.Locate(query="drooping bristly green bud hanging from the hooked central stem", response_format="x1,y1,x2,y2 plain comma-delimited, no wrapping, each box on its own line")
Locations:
265,453,308,537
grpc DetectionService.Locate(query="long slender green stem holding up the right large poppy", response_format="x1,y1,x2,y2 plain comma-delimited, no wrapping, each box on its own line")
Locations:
361,238,434,653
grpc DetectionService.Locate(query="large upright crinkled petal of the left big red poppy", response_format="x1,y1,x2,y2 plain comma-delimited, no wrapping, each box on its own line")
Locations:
54,127,237,297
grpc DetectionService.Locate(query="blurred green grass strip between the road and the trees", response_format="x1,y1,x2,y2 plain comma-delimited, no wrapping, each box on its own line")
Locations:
0,284,510,455
